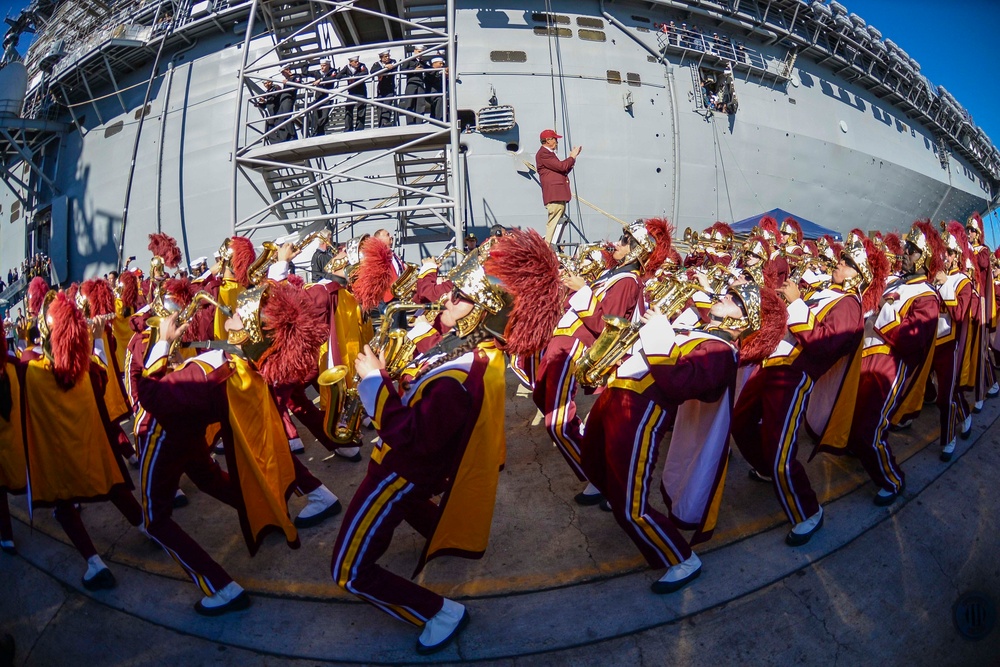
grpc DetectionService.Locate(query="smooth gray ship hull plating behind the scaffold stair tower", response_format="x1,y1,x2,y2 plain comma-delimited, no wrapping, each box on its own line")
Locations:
0,2,991,280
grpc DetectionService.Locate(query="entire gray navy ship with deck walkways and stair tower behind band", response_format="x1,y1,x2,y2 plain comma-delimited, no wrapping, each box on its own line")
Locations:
0,0,1000,296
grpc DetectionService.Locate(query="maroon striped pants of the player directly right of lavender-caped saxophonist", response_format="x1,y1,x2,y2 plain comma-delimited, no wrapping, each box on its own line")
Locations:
732,366,819,524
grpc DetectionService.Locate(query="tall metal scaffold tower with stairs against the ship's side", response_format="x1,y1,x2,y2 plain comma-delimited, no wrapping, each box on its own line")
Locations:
232,0,464,252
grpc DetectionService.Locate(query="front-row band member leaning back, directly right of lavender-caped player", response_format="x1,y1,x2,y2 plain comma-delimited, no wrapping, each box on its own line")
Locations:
733,232,873,546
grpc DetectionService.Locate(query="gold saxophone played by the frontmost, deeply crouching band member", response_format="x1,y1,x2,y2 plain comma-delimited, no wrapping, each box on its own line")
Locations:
316,303,425,447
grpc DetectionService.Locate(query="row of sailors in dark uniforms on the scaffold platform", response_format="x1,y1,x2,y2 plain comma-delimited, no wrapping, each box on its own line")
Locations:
252,44,448,143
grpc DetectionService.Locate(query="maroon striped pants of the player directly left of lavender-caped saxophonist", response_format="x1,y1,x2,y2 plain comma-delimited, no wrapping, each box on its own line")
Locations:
532,336,587,482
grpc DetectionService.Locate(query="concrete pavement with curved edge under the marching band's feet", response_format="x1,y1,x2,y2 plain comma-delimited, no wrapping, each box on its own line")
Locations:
0,374,1000,665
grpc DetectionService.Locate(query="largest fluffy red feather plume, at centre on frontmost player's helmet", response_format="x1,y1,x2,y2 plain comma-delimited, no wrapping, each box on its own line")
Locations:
484,229,564,355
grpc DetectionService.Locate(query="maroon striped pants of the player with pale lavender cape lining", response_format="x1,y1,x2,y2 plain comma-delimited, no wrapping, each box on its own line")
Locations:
582,387,691,568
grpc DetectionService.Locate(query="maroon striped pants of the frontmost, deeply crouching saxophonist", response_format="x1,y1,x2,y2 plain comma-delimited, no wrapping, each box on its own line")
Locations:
330,462,444,625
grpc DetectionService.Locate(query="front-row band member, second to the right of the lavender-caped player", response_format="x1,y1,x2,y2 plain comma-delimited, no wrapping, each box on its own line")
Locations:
847,221,944,506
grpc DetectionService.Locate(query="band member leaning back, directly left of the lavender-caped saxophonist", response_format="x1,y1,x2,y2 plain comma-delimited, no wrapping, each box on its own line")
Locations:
532,218,670,505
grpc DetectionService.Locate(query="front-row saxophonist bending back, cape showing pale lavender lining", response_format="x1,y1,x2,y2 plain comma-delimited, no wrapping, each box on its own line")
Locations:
582,282,787,593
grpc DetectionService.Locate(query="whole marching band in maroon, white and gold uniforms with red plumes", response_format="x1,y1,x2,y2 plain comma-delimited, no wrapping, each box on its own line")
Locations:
0,215,1000,653
